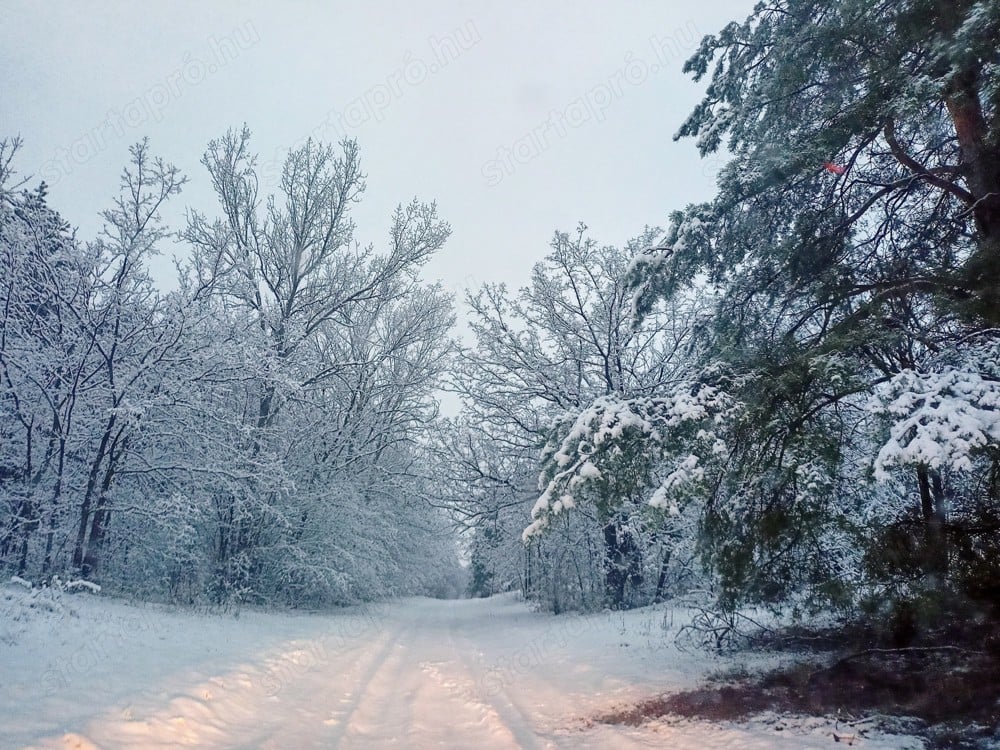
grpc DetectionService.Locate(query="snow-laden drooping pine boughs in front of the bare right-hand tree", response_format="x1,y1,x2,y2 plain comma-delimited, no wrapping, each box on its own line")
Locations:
522,383,734,542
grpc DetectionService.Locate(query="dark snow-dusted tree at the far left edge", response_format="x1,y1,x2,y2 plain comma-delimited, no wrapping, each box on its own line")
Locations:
0,139,89,575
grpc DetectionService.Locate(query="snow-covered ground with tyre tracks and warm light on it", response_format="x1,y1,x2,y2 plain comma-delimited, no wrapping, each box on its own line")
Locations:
0,586,922,750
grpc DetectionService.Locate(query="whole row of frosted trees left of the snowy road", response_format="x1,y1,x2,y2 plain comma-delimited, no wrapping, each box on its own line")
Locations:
0,128,459,605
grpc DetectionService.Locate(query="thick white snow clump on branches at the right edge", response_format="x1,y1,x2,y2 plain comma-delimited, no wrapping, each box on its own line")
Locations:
873,342,1000,481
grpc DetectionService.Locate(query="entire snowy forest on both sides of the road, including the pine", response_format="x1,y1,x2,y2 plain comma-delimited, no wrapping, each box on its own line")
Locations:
0,0,1000,645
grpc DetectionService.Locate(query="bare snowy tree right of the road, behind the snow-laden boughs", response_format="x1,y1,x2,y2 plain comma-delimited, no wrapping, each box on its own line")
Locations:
457,226,694,608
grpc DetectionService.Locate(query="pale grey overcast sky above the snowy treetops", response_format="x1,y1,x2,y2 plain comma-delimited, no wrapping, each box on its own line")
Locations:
0,0,752,302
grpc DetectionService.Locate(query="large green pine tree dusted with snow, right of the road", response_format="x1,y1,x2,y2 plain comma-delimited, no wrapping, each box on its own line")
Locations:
632,0,1000,603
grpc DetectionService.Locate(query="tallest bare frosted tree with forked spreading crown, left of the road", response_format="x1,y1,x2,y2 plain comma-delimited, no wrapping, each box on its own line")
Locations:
184,127,451,604
